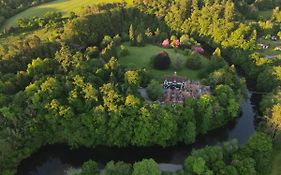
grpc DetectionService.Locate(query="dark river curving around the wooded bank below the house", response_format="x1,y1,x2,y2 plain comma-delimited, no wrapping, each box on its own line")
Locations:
17,86,259,175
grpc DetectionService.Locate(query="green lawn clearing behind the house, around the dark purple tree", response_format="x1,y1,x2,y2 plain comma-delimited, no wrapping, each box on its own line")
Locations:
119,44,208,80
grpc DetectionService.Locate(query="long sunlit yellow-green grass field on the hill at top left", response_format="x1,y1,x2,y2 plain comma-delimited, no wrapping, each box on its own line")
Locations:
1,0,133,30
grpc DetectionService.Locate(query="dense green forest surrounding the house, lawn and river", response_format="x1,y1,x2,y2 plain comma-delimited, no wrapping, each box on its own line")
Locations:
0,0,281,175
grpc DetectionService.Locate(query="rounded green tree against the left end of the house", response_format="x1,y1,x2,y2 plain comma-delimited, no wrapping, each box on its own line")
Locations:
147,80,163,101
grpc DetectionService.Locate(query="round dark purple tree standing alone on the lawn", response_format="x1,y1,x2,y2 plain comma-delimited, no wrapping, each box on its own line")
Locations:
153,51,171,70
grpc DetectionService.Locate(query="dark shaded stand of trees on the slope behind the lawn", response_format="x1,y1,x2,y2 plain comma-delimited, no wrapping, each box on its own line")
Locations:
61,7,169,46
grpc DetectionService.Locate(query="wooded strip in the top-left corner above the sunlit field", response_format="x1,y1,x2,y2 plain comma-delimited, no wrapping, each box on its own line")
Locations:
0,0,52,26
